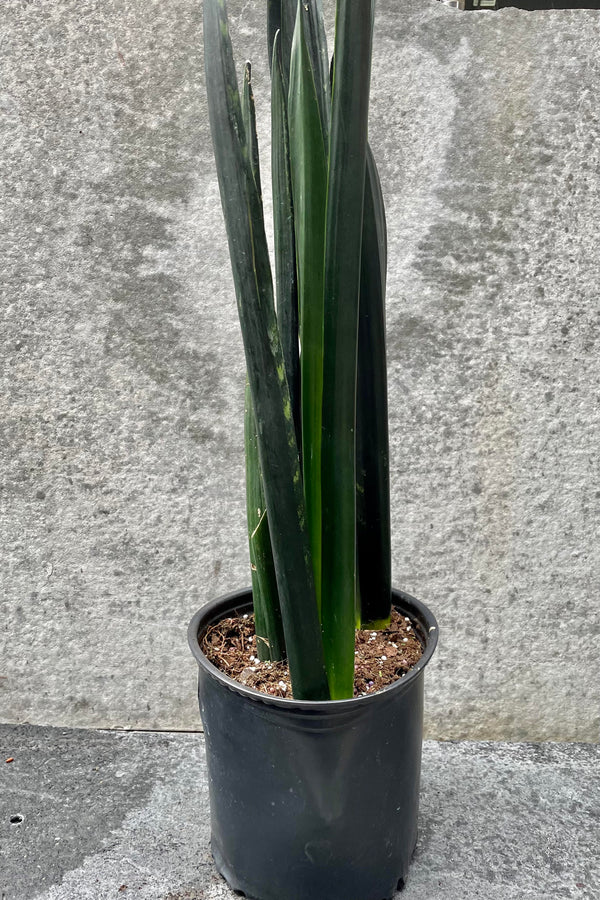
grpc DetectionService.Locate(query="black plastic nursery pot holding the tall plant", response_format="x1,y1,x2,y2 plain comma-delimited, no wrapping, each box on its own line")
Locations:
188,590,438,900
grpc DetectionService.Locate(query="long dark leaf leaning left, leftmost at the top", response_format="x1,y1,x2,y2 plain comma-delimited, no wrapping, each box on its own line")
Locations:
204,0,329,700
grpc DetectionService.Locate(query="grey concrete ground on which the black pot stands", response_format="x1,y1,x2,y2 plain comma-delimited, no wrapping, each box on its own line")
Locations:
0,725,600,900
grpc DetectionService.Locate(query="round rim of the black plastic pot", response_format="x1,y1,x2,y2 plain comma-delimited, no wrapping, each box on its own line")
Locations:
187,587,439,713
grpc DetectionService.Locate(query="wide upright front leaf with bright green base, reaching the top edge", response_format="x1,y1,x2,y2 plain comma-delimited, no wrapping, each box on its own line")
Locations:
321,0,374,699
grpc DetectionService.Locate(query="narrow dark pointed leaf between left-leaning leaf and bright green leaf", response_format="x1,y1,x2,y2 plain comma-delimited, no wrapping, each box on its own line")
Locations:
271,32,302,447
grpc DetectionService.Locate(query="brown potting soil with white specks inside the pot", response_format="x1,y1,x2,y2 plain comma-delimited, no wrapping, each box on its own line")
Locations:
200,609,423,698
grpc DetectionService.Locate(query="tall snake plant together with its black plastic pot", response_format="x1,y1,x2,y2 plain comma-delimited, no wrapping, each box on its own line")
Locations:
189,0,437,900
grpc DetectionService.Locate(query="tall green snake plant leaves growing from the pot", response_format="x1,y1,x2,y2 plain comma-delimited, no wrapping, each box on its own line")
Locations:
204,0,391,700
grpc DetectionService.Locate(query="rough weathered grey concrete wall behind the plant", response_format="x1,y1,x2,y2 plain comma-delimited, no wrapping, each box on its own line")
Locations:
0,0,600,741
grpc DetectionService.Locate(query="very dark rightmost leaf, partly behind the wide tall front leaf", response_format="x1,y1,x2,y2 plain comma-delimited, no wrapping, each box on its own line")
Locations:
356,148,392,628
